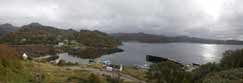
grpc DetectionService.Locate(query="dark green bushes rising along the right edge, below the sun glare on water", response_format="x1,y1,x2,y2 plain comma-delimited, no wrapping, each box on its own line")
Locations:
192,49,243,83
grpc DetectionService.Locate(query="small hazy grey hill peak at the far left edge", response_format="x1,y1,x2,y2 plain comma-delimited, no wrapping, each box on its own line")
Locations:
0,24,18,37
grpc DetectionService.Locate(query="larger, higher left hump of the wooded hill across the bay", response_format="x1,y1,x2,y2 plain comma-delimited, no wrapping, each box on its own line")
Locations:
2,23,74,45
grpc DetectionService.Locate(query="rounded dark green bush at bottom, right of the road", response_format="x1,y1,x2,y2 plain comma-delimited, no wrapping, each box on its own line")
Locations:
146,61,191,83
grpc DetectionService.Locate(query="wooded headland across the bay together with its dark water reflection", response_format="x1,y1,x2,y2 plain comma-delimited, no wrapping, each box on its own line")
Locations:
0,23,121,58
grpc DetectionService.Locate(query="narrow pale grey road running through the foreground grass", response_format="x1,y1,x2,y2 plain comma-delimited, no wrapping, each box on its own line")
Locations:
64,66,146,83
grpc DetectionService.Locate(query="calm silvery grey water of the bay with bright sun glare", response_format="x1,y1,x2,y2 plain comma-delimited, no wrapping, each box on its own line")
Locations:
58,42,243,65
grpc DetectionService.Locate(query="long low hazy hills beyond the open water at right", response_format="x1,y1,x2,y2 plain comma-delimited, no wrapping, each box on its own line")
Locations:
111,33,243,45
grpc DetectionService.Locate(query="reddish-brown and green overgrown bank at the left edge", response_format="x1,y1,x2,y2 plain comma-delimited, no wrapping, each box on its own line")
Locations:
0,45,31,83
